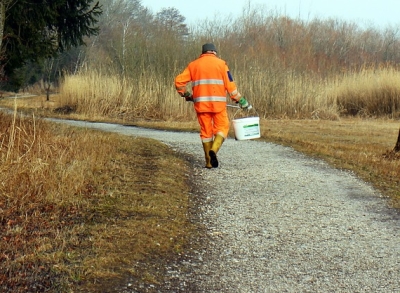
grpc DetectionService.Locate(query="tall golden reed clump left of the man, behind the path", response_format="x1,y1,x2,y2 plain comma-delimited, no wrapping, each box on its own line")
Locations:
60,70,192,119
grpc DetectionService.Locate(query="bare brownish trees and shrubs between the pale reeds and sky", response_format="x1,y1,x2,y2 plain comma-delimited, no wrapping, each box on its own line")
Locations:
80,0,400,77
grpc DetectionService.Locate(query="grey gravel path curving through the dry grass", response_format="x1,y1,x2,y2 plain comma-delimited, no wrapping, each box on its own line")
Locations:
48,122,400,293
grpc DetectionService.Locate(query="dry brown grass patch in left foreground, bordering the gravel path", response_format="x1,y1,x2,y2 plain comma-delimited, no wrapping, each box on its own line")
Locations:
0,108,192,293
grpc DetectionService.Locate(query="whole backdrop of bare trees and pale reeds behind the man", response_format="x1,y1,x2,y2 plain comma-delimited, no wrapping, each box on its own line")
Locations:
60,3,400,120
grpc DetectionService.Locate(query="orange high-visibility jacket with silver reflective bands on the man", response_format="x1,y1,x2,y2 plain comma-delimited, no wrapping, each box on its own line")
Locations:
175,53,241,113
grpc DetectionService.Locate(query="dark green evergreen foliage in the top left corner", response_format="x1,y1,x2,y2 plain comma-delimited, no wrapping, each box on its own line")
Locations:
1,0,102,88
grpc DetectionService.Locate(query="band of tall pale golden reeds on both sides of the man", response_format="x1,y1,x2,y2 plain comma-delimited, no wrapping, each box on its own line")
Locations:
61,67,400,120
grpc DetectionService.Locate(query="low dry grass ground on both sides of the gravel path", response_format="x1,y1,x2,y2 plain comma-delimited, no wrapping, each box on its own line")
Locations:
0,97,400,292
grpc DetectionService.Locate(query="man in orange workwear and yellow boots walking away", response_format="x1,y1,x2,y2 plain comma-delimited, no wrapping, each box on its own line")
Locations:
175,43,251,168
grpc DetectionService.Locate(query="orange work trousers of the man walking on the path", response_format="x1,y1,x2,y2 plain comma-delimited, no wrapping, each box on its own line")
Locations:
197,109,230,142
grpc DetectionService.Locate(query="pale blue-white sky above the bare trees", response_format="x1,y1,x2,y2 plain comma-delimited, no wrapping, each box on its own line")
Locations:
141,0,400,29
